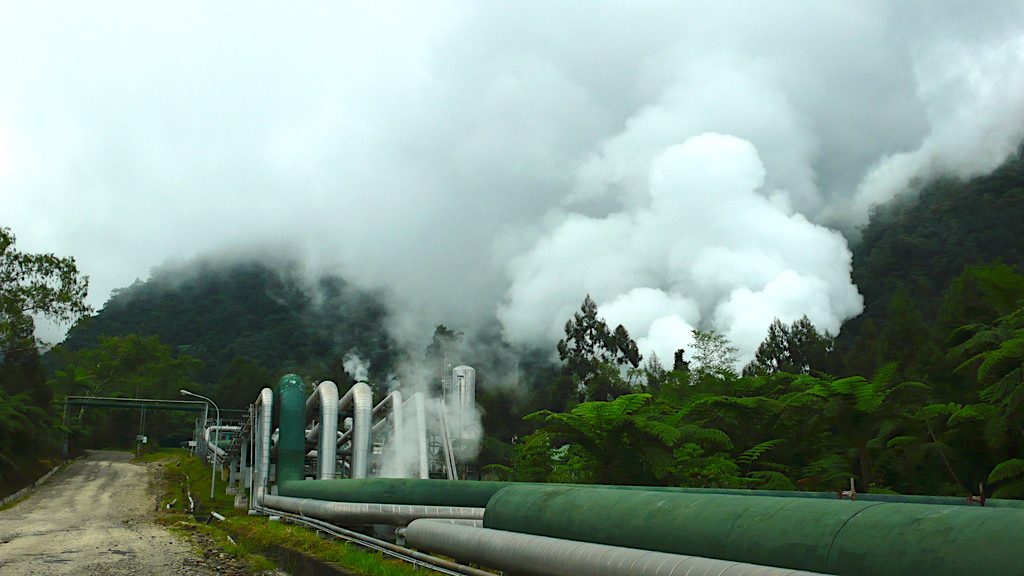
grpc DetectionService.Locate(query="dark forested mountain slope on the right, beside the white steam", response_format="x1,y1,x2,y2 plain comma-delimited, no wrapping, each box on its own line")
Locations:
831,147,1024,379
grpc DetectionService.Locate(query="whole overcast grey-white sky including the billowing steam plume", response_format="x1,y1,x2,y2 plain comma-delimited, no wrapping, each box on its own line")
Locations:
0,1,1024,358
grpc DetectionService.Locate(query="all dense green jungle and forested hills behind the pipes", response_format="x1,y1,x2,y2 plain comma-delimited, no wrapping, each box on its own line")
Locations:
0,150,1024,497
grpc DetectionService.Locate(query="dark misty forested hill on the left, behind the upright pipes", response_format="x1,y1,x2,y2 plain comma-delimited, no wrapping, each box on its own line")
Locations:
55,260,392,382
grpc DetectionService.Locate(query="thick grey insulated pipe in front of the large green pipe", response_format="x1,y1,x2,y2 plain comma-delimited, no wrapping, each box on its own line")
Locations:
399,520,818,576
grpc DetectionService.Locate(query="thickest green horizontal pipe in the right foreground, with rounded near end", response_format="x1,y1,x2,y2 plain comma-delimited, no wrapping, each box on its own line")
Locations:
483,486,1024,576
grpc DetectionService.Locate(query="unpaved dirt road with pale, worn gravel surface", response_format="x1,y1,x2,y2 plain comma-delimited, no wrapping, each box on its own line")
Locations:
0,451,212,576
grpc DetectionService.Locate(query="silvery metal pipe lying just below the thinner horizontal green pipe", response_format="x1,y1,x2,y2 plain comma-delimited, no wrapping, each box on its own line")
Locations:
263,487,483,526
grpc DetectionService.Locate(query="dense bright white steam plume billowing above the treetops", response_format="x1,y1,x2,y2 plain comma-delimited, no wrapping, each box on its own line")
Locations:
499,133,862,360
